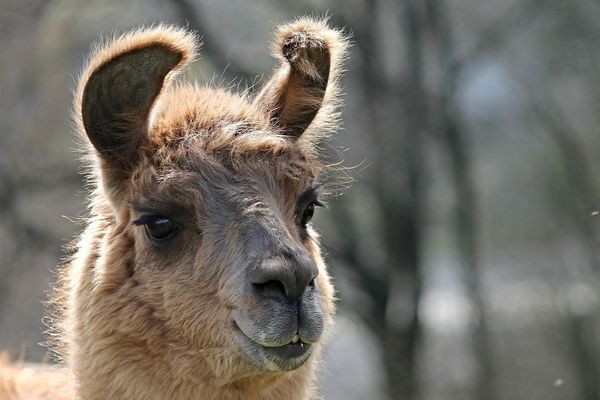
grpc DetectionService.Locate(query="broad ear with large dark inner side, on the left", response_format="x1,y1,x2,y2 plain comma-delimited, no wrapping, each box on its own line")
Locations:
76,26,196,170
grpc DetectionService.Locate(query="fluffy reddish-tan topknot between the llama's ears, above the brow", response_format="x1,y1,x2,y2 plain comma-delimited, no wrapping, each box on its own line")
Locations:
149,85,320,178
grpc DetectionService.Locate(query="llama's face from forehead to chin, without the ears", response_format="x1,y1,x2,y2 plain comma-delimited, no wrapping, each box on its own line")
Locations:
126,116,332,371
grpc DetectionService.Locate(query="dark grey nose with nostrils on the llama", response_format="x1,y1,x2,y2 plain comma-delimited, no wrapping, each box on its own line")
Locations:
252,251,319,300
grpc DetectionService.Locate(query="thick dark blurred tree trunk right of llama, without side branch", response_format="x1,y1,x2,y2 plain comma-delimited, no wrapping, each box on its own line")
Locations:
370,0,429,400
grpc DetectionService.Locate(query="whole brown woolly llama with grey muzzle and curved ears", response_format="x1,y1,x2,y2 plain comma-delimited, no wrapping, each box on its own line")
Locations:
0,18,347,400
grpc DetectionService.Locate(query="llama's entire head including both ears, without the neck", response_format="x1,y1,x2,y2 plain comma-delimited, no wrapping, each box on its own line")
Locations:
76,20,345,378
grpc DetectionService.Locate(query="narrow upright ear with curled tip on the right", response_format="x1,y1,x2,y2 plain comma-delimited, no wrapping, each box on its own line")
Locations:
254,18,347,138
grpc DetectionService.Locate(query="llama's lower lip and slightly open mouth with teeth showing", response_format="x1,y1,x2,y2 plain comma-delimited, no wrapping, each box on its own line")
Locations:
233,321,313,372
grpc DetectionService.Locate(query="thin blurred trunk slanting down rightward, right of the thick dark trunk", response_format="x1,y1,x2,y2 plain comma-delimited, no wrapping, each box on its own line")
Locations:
425,0,497,400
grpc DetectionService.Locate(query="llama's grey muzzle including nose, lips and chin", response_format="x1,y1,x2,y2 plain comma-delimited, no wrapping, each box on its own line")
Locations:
234,251,324,371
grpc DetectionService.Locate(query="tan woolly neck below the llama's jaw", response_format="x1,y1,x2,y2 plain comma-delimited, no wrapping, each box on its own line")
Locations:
73,332,316,400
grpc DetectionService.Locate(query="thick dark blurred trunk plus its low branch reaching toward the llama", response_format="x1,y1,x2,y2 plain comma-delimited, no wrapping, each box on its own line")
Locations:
326,0,428,400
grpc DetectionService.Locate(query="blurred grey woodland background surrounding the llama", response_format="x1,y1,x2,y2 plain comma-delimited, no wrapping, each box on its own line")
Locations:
0,0,600,400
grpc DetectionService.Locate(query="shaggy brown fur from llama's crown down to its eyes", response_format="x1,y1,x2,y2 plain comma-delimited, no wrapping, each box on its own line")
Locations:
132,85,321,228
